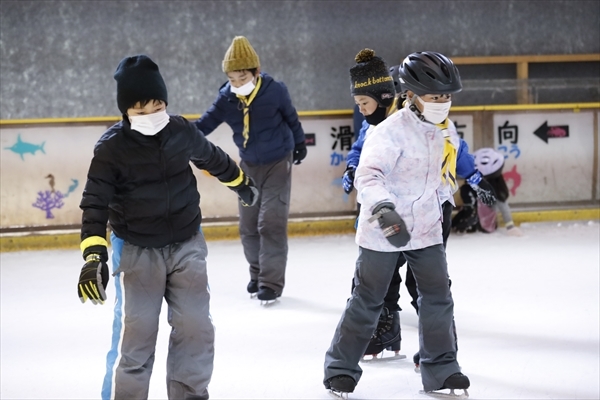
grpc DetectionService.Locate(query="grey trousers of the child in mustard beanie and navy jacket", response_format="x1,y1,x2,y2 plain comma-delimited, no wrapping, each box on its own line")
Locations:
239,153,292,294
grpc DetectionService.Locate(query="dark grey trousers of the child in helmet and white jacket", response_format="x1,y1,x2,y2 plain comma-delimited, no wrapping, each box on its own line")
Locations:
324,244,460,391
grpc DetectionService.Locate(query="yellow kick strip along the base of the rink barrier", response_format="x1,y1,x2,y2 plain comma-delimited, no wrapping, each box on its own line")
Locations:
0,208,600,253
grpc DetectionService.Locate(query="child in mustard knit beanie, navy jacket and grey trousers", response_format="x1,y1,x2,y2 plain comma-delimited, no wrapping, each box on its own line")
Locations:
196,36,306,301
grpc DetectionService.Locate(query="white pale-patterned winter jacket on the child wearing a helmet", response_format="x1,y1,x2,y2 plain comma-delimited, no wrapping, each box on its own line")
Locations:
354,106,460,252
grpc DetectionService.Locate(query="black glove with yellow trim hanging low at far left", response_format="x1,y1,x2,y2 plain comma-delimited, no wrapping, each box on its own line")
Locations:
77,236,109,304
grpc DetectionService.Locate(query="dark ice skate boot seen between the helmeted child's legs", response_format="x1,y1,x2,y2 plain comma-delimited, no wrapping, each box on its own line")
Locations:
363,307,406,361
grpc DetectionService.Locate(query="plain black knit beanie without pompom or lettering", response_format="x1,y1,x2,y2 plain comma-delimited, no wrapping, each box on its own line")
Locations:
114,54,167,114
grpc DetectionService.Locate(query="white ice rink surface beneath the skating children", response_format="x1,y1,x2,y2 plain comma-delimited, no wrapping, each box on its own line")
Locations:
0,221,600,400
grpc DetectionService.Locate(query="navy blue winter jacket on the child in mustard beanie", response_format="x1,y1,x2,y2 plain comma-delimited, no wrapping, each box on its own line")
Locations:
195,73,304,165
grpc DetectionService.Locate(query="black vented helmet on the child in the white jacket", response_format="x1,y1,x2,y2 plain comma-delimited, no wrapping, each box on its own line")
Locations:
398,51,462,96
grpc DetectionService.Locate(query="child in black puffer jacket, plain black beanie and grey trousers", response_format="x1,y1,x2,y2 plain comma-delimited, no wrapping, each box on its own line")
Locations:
77,55,258,399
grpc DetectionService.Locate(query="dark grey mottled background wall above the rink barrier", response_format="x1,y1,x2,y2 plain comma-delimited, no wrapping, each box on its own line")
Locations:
0,0,600,119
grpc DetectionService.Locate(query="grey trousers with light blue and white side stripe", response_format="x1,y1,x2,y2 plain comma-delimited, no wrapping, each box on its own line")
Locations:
102,232,215,400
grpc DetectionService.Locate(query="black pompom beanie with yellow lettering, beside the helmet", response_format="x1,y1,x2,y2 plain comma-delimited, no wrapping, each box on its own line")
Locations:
350,49,396,107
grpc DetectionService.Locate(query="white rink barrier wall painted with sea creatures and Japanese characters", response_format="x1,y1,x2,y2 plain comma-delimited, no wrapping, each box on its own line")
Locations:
0,102,600,248
